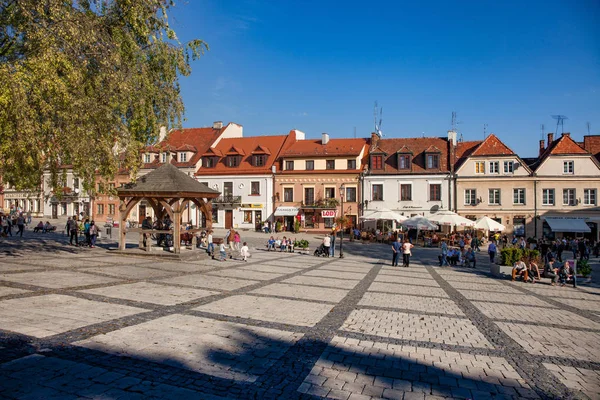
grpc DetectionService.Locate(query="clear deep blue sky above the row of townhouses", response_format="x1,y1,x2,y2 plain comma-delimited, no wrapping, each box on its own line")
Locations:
171,0,600,156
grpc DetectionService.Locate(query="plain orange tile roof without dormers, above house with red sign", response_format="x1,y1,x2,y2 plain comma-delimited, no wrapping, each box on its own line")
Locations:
279,139,367,158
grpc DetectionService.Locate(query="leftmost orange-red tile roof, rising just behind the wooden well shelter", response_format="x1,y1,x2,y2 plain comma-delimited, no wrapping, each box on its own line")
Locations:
142,126,226,168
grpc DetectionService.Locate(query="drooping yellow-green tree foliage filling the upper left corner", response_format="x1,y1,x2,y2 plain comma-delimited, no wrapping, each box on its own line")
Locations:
0,0,208,192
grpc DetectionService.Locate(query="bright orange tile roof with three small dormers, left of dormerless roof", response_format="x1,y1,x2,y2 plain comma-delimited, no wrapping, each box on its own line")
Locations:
196,135,288,176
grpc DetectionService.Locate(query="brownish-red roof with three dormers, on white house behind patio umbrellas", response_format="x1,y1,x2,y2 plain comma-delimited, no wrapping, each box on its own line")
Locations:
371,138,450,174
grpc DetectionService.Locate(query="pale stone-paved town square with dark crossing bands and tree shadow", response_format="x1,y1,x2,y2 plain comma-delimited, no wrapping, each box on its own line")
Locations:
0,235,600,400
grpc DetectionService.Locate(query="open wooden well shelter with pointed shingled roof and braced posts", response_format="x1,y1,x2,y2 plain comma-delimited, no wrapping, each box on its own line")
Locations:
117,164,220,253
